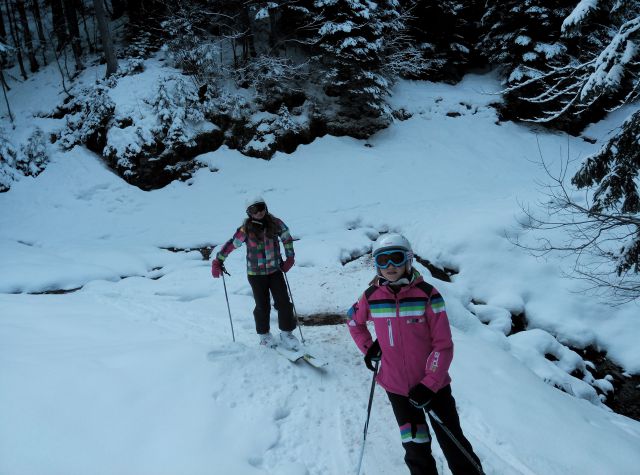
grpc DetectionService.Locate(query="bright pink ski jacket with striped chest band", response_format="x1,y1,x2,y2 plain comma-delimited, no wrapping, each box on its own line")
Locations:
347,270,453,396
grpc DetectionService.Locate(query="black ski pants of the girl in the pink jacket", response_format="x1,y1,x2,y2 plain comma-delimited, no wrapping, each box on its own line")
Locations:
387,385,482,475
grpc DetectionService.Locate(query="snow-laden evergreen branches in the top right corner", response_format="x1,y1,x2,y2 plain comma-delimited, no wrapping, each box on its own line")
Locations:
498,0,640,133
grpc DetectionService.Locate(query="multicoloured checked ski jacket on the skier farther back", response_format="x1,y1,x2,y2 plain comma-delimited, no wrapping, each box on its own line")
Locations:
216,216,294,275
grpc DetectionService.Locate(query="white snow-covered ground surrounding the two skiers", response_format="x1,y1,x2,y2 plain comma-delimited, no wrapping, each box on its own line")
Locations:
0,60,640,475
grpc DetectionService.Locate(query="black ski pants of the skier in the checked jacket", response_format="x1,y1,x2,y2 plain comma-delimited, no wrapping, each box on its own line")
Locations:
248,271,296,335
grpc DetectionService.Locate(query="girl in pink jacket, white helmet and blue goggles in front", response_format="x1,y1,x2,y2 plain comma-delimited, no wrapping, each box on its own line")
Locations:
348,234,480,475
